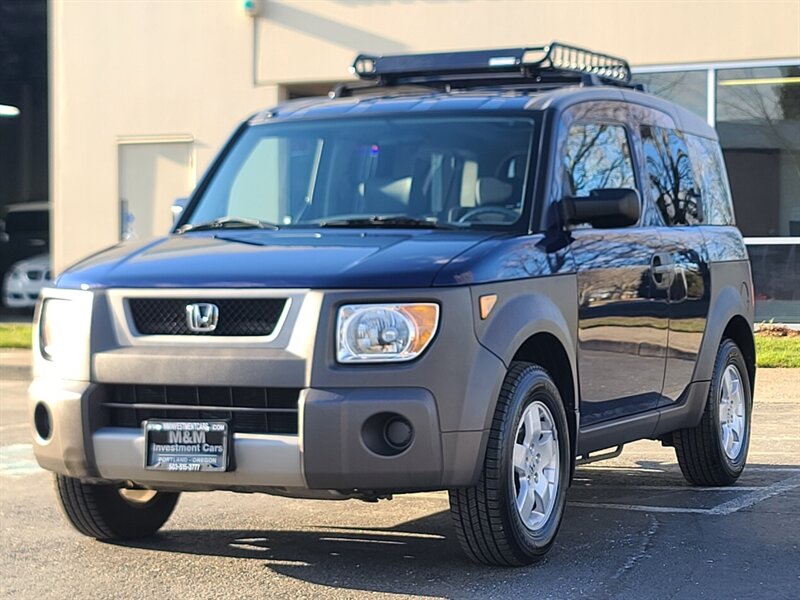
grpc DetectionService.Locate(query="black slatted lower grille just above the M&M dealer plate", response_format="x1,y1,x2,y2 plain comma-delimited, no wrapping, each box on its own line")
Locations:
103,384,300,435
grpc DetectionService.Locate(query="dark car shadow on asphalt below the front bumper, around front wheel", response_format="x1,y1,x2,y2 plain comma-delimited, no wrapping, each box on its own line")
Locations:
119,504,628,598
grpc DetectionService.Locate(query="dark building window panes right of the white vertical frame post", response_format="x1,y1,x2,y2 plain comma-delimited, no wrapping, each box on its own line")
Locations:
716,65,800,323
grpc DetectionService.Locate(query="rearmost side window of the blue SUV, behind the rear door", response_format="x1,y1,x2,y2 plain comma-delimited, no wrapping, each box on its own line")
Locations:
686,135,734,225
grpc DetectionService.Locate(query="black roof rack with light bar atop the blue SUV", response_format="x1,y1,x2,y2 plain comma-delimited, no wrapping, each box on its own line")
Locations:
336,42,631,95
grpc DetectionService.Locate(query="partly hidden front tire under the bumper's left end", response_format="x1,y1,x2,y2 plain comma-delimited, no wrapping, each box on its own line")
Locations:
55,475,180,541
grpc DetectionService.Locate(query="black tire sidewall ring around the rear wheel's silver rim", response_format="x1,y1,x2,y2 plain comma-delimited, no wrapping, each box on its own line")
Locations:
708,340,753,478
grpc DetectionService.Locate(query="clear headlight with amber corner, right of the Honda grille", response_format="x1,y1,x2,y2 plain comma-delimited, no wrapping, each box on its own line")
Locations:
336,303,439,363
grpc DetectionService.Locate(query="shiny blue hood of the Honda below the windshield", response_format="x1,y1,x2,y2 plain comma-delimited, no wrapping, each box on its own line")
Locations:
57,229,493,289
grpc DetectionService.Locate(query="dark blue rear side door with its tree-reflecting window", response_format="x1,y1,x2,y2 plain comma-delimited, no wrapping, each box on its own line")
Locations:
640,125,711,405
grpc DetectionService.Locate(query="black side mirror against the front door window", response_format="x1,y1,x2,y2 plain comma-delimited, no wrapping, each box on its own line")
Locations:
560,188,641,229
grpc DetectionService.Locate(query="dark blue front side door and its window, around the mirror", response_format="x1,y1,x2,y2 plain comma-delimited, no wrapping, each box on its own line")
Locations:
559,103,670,427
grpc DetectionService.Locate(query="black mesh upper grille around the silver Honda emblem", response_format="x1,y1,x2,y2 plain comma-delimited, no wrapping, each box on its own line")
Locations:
128,298,286,336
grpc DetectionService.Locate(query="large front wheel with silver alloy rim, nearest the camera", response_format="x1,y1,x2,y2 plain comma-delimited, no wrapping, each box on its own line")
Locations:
449,362,571,566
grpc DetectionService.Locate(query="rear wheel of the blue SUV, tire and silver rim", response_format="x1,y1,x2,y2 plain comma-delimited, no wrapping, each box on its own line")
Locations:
673,339,753,486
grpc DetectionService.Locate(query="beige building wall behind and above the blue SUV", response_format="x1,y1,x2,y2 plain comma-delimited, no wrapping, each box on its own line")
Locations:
50,0,800,270
